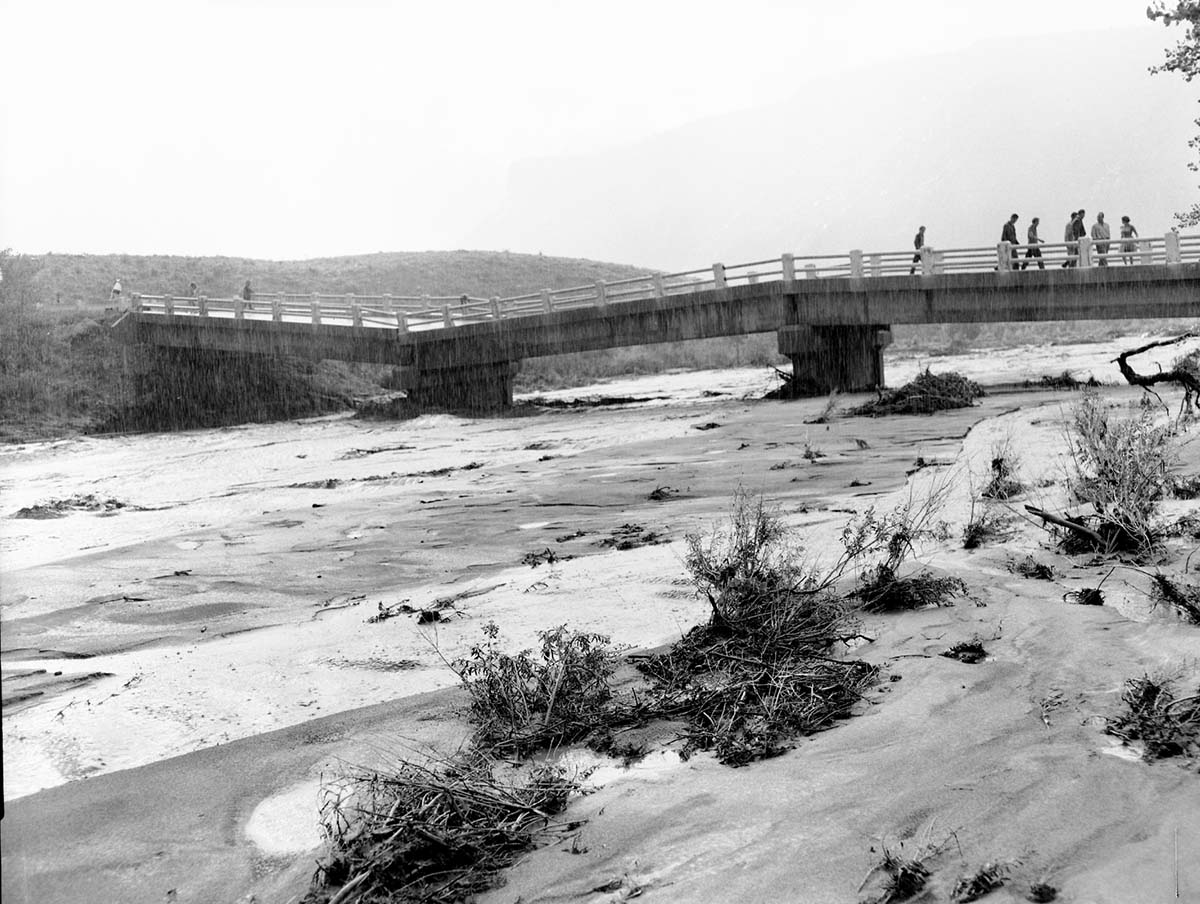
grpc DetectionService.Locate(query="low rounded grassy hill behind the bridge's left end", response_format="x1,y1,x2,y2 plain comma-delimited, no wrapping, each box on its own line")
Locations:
9,251,647,305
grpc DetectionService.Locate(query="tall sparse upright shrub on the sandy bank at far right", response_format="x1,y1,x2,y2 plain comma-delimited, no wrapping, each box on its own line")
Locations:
1058,391,1175,555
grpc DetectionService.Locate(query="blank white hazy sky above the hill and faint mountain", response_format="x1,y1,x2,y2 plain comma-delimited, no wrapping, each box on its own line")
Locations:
0,0,1195,263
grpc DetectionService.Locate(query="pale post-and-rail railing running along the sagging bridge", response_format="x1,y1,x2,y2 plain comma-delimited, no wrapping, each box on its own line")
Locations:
126,233,1200,333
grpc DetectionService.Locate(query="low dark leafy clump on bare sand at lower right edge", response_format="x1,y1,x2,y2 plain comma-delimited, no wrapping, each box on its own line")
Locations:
1104,675,1200,760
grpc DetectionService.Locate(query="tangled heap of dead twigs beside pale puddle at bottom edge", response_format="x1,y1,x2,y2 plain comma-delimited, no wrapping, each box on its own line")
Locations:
305,753,578,904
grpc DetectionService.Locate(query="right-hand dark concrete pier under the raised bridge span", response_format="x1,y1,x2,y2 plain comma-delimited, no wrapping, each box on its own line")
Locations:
779,324,892,395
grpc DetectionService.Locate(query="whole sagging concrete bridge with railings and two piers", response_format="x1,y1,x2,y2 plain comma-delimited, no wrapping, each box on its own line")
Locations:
116,233,1200,409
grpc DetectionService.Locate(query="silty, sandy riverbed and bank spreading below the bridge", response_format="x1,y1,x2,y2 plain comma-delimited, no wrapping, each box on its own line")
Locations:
0,342,1200,904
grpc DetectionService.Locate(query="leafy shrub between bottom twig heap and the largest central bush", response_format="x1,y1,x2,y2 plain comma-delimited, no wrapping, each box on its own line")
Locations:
451,624,618,754
